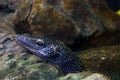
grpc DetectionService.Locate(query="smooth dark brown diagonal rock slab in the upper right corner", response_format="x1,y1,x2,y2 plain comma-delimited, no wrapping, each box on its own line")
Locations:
88,0,120,32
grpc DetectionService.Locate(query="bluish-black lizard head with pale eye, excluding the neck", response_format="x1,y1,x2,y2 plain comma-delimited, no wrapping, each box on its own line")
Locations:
16,34,71,64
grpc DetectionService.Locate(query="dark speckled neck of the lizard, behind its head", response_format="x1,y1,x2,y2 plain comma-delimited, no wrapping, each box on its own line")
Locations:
58,56,85,74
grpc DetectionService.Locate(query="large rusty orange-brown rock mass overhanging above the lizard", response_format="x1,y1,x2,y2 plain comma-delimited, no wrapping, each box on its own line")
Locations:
14,0,120,45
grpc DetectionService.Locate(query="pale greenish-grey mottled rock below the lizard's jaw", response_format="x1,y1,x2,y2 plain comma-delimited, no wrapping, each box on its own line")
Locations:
0,47,58,80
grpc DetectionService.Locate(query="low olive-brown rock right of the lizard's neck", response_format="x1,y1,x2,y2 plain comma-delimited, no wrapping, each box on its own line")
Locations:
80,45,120,80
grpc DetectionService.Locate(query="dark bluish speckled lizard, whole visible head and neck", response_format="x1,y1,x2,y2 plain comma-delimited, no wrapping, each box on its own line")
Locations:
16,34,85,74
